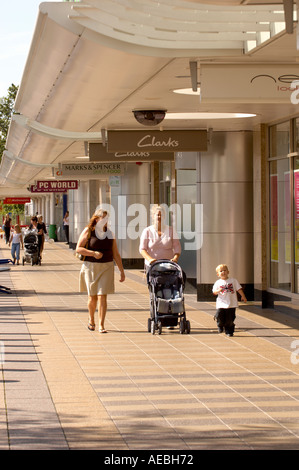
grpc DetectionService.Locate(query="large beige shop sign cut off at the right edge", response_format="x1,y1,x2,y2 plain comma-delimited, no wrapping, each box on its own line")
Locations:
200,64,299,103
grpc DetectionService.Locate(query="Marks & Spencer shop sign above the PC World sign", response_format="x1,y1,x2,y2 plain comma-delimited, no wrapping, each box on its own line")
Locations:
59,162,125,178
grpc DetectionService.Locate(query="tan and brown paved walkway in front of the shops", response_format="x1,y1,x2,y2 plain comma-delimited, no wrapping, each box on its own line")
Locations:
0,240,299,452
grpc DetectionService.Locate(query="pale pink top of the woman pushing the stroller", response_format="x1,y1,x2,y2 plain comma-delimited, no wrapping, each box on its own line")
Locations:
139,225,181,265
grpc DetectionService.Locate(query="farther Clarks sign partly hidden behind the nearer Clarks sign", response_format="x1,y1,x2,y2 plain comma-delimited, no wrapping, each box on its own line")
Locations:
89,143,174,162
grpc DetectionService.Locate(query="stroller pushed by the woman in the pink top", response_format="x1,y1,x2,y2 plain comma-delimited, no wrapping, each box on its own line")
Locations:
147,260,190,335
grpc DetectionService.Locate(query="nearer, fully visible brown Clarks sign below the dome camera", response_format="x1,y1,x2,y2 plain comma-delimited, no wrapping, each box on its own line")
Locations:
108,130,207,153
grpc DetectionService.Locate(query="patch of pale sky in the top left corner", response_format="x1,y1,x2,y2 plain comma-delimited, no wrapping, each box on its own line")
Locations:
0,0,61,97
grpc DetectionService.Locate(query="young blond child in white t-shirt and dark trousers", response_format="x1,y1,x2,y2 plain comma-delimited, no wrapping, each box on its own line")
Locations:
213,264,247,336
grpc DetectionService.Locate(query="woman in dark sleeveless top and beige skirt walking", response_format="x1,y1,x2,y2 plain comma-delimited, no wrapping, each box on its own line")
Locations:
76,208,125,333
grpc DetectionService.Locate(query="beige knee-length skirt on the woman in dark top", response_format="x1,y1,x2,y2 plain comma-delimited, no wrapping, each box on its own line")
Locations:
79,261,114,295
